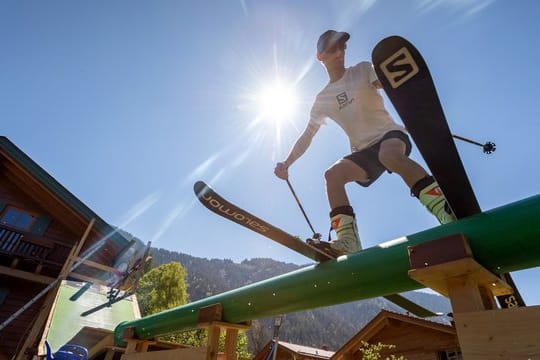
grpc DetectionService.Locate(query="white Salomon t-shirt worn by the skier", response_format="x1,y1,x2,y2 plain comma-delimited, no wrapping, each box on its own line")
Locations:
309,61,405,152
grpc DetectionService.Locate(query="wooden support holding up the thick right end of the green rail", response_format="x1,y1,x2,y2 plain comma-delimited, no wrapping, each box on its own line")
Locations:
409,234,540,359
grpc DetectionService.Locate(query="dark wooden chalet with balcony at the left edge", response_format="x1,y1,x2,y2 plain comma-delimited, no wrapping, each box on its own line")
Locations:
0,136,132,360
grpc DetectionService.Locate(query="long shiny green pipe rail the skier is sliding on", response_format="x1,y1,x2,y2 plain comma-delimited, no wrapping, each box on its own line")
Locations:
114,195,540,345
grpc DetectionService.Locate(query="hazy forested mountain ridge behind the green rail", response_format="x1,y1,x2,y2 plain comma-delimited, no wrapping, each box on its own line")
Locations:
148,248,451,351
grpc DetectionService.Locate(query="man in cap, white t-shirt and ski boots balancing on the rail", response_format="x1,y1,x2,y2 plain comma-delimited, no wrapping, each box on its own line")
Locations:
274,30,455,253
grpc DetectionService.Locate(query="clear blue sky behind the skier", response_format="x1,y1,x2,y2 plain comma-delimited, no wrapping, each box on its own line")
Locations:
0,0,540,305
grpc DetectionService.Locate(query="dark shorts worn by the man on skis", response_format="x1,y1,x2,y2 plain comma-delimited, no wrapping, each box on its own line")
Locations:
344,130,412,187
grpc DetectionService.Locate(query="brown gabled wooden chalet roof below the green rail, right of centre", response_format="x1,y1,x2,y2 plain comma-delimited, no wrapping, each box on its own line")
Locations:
332,310,462,360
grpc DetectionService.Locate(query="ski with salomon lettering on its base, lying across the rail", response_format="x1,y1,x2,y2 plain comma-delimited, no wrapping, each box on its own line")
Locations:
193,181,440,317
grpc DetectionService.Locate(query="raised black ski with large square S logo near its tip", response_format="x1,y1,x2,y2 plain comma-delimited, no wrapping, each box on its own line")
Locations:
372,36,525,307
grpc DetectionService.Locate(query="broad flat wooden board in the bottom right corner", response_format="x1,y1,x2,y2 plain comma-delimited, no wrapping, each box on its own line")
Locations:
454,306,540,360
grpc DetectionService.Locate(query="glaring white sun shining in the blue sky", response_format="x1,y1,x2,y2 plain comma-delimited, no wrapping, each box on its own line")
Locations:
255,79,298,124
